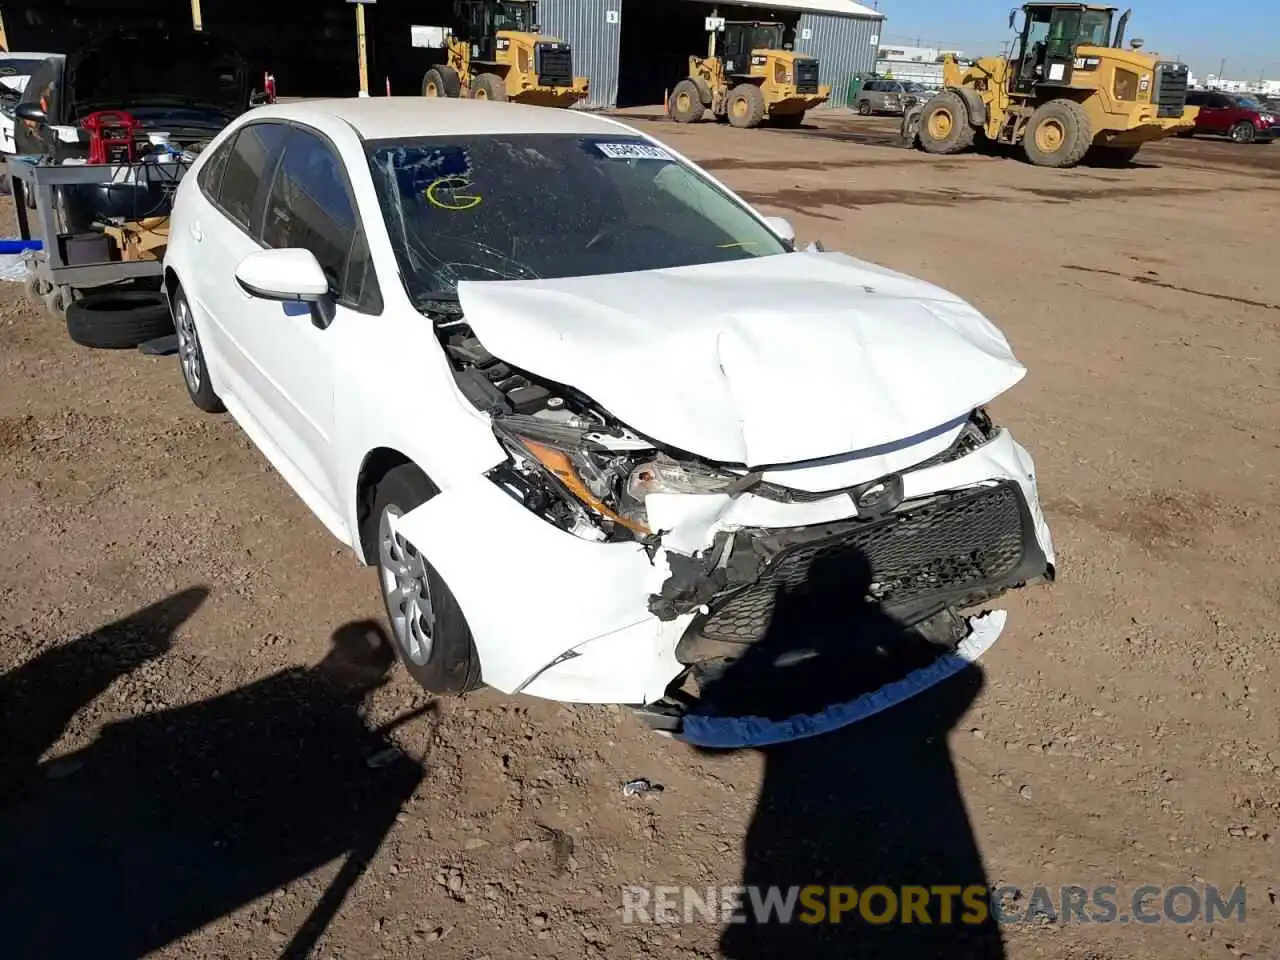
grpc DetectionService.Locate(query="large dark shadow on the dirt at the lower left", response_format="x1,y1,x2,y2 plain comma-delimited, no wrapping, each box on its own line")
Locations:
0,590,424,960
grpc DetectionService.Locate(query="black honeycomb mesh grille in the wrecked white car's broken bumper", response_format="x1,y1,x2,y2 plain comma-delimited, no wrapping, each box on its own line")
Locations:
699,481,1044,644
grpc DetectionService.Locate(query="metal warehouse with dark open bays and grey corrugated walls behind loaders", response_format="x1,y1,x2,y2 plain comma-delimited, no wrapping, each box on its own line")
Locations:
0,0,883,109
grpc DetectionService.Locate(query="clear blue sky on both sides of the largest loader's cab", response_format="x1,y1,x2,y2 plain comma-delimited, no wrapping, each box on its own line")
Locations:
875,0,1280,79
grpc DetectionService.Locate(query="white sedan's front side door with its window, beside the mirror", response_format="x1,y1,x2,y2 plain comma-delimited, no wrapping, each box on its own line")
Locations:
243,125,381,509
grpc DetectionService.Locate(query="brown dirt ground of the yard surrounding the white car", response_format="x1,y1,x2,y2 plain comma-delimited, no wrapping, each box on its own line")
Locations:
0,113,1280,960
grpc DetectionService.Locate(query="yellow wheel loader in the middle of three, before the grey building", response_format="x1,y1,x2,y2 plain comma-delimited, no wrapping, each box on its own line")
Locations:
667,17,831,128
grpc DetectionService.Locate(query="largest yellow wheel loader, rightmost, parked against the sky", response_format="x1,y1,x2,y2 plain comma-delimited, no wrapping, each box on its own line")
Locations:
902,3,1198,166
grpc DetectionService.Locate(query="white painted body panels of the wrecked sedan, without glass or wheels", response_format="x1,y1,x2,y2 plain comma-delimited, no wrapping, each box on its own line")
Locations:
165,97,1053,704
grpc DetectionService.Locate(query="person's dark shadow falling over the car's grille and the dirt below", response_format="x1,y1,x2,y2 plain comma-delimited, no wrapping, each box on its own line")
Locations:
704,558,1005,960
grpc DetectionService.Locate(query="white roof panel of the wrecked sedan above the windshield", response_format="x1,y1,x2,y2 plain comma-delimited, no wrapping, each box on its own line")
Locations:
239,97,636,140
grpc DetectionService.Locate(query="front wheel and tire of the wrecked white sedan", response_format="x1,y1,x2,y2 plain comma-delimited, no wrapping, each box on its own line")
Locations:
369,463,481,694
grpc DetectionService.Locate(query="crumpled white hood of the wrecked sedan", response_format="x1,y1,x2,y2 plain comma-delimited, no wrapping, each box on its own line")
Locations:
458,253,1025,467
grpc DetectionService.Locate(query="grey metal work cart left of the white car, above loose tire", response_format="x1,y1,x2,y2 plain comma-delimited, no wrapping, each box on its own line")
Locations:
6,156,189,315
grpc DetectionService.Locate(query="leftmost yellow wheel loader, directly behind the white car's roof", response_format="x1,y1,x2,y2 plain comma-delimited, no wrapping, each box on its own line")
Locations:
422,0,590,106
